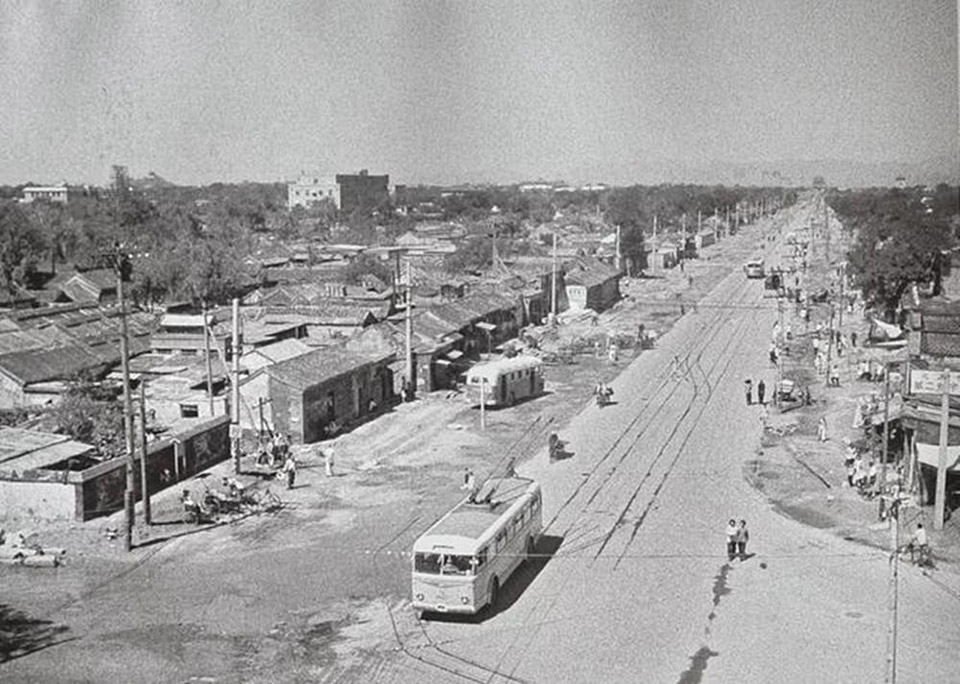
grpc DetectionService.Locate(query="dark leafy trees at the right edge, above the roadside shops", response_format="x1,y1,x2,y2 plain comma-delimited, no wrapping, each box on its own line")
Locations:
827,185,960,321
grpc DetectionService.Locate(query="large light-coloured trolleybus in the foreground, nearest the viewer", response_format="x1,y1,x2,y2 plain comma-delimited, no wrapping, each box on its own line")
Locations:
412,476,543,615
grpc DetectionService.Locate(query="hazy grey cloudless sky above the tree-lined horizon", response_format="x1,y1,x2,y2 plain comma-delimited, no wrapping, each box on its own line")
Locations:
0,0,960,184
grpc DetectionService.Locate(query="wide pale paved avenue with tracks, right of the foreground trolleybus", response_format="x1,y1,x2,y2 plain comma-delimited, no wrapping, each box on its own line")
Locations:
352,205,960,684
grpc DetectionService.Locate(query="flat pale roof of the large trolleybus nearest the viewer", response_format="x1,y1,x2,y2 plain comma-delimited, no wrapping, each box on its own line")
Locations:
414,477,539,553
